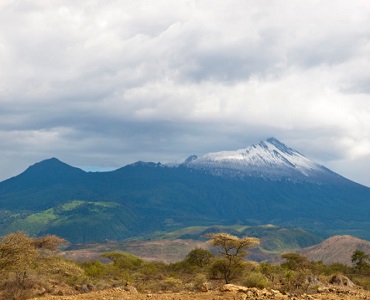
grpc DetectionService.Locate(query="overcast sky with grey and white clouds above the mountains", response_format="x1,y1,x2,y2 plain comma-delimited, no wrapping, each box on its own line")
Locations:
0,0,370,186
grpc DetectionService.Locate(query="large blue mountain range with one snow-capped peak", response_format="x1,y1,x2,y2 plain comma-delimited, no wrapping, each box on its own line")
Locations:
0,138,370,243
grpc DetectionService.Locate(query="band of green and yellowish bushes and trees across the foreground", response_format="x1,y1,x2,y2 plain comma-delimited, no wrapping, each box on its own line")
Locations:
0,232,370,299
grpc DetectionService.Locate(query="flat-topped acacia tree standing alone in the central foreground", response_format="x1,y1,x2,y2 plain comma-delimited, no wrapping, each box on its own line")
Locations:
206,233,260,283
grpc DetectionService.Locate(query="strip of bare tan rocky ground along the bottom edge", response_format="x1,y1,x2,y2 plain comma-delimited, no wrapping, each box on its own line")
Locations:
34,285,370,300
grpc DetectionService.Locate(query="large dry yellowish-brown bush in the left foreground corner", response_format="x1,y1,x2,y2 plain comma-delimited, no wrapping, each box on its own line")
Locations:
0,231,76,299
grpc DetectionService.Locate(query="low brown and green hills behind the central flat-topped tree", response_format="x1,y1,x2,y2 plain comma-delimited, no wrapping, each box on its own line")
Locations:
63,225,321,262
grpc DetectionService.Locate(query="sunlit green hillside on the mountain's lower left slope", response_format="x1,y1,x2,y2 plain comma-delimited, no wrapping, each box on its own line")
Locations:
4,200,137,243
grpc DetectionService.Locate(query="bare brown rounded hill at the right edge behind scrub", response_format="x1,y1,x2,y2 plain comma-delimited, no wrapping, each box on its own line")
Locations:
299,235,370,266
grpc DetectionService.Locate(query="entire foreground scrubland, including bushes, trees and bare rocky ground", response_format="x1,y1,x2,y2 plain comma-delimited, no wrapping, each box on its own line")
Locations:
0,232,370,300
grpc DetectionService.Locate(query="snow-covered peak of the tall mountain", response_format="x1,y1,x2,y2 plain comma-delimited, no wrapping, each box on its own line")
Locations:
181,138,341,182
